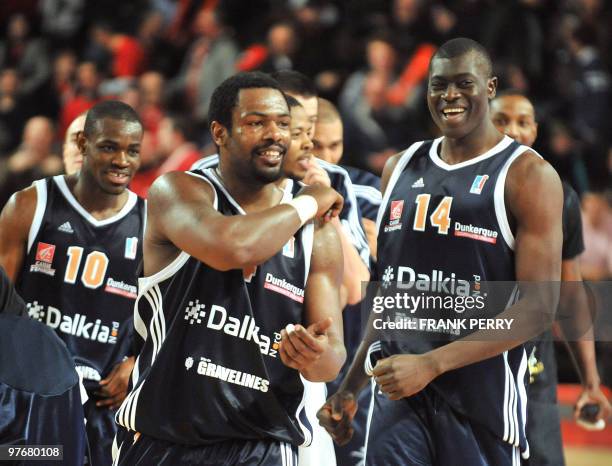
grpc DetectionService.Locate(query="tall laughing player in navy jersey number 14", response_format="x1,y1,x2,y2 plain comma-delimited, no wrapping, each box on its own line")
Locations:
319,38,562,466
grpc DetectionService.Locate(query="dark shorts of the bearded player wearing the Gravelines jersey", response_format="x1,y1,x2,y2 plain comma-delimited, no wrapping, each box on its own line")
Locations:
113,428,298,466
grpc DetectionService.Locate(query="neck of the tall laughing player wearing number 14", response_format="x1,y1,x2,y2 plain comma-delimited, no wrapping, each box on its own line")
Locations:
440,123,504,165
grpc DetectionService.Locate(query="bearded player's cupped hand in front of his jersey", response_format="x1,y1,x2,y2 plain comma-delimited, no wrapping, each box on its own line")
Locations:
279,317,332,372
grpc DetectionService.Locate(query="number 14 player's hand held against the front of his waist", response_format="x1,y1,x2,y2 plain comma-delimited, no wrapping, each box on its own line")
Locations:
372,354,438,400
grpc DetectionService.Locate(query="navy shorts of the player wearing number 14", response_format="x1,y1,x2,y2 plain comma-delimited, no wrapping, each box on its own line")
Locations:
366,384,521,466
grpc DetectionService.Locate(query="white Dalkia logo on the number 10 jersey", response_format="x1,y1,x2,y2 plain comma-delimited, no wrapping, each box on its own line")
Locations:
27,301,119,345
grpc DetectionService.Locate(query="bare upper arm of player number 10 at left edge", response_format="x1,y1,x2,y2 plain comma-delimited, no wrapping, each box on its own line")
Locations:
0,186,37,282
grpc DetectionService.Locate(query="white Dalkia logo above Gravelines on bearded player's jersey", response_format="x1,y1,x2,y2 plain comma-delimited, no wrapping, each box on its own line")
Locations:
184,299,281,358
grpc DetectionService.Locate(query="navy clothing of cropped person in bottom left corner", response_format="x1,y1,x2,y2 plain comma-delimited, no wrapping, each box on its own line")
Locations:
0,314,87,466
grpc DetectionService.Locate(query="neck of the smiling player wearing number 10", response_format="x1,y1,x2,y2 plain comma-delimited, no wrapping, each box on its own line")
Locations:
66,174,129,220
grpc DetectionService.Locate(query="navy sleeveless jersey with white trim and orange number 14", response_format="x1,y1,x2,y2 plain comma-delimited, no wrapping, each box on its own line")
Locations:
373,137,528,454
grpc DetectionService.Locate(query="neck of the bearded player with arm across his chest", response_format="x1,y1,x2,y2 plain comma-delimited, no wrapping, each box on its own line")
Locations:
215,168,283,213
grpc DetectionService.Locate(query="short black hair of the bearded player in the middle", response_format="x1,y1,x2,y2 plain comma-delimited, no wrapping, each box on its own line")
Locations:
208,71,289,131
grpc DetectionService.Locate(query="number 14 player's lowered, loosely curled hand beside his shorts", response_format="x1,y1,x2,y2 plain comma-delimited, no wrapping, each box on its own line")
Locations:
317,391,357,446
